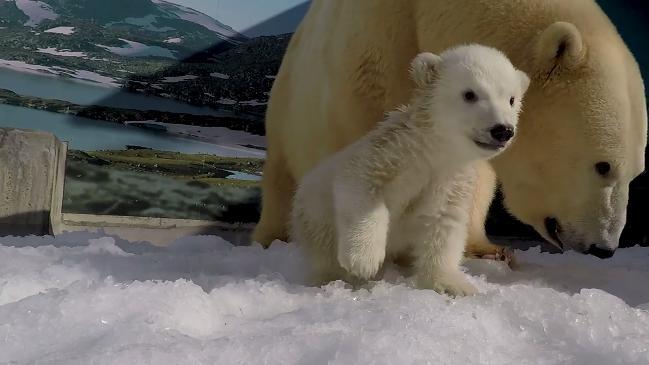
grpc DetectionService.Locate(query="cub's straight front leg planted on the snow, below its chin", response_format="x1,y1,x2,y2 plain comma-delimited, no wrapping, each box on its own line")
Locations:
408,176,477,296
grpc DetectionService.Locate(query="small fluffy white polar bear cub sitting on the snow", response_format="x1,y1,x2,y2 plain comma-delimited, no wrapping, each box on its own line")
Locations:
290,44,530,295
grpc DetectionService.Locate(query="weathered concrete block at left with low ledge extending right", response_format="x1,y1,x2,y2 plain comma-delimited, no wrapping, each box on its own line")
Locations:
0,128,254,245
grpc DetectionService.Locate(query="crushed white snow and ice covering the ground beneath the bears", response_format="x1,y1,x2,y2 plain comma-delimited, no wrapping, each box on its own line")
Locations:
0,234,649,365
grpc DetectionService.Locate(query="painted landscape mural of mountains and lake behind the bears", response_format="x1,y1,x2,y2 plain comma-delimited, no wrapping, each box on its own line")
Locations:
0,0,649,243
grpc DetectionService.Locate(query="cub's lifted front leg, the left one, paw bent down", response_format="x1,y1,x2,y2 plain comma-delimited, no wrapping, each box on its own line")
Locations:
333,177,389,280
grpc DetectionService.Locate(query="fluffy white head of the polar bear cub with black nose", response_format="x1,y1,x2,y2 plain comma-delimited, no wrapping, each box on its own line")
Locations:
410,44,530,158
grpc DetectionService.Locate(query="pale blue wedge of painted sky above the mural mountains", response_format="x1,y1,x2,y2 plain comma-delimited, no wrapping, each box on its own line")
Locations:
168,0,306,32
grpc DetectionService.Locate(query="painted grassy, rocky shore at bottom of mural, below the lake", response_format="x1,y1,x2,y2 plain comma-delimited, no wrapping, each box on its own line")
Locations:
63,148,263,223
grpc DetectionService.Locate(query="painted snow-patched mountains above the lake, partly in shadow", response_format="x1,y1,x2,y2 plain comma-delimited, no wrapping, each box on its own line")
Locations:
0,0,290,111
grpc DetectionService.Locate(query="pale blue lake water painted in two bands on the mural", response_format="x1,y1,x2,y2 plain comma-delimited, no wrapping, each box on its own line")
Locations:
0,68,259,157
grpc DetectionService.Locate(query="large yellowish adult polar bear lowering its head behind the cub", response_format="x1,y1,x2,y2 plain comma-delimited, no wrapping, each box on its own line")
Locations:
253,0,647,257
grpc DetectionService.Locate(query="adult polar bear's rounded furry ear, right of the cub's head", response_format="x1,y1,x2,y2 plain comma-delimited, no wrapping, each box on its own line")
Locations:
534,22,586,81
